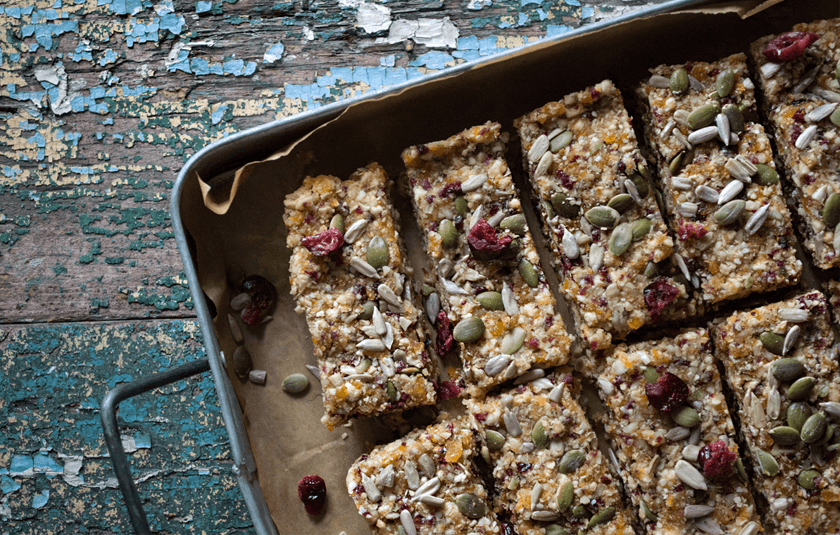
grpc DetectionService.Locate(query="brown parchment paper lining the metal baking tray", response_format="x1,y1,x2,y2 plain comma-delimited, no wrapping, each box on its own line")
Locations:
176,0,840,535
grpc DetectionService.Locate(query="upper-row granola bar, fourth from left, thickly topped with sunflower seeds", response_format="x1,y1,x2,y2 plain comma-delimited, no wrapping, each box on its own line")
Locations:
638,54,802,305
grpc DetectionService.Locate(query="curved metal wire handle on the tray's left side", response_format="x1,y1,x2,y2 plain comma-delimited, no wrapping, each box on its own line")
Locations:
100,358,210,535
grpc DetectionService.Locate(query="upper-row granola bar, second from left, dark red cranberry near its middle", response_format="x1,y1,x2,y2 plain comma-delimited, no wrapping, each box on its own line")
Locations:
402,122,571,394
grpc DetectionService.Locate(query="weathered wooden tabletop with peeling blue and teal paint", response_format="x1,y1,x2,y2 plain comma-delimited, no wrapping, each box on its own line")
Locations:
0,0,664,534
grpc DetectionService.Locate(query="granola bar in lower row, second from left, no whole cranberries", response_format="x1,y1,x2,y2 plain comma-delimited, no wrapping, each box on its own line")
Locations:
465,369,633,535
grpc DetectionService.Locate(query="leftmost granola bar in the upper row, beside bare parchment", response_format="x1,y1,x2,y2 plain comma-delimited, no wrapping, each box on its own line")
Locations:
283,164,437,429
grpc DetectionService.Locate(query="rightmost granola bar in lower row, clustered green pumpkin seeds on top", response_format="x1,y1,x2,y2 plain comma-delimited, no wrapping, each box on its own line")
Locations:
714,292,840,533
